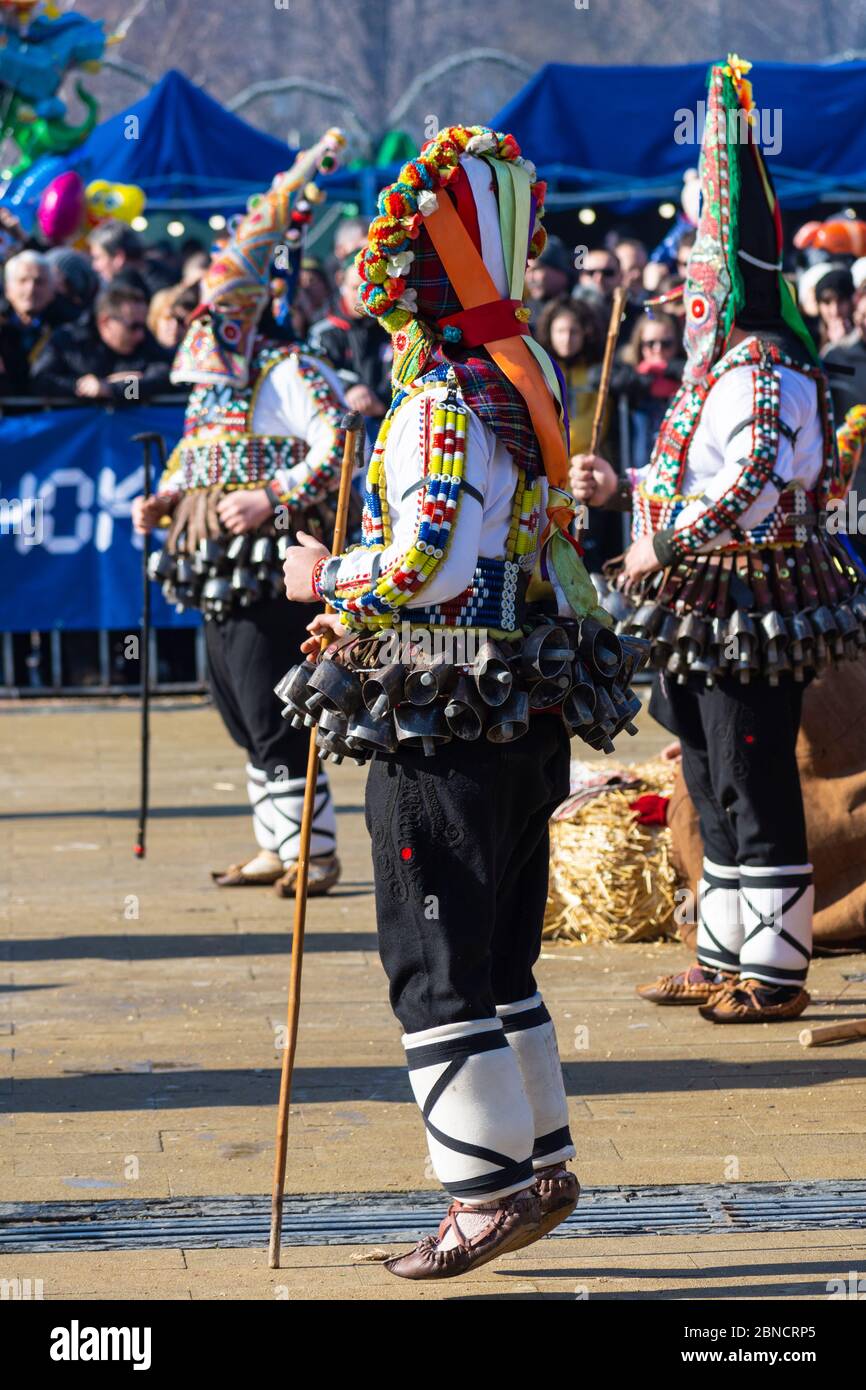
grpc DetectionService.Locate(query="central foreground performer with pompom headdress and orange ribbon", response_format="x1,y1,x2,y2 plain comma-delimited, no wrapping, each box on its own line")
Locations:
281,126,642,1279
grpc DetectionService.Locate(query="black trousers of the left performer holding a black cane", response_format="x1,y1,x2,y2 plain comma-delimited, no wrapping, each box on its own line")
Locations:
204,598,318,781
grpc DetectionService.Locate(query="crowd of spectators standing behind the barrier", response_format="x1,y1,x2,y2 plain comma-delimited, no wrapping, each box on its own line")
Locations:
0,198,866,439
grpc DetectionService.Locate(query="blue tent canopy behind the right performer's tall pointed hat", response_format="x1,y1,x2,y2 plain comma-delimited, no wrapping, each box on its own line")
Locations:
491,61,866,207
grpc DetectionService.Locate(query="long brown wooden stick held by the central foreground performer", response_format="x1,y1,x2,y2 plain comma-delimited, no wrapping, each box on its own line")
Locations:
268,410,363,1269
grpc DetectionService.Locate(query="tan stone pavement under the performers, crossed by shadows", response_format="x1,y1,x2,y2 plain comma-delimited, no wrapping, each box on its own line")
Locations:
0,701,866,1298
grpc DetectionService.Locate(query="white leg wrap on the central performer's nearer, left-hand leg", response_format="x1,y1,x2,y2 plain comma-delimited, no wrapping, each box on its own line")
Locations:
403,1019,535,1202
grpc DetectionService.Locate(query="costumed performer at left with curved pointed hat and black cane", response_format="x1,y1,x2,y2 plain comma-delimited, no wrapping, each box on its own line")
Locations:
133,131,343,897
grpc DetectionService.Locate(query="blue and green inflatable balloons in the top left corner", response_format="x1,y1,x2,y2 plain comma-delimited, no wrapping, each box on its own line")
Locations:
0,0,111,179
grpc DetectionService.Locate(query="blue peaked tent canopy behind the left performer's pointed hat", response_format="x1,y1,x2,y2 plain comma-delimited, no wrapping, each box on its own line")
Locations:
4,71,295,217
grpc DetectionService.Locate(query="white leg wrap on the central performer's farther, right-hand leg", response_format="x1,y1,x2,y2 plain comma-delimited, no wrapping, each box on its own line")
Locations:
496,994,574,1168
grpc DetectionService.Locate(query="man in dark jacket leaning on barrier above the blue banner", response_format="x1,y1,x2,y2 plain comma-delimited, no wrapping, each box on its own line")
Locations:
32,286,170,400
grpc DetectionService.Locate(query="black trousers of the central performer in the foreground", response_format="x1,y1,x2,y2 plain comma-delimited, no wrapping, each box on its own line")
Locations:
366,714,570,1033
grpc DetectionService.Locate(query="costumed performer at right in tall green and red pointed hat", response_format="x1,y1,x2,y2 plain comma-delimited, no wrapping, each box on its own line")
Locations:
574,58,866,1023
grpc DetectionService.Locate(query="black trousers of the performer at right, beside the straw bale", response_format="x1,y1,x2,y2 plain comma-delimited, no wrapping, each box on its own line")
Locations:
649,674,809,867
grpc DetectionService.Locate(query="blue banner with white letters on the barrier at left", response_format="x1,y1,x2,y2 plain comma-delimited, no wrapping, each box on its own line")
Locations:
0,406,191,632
